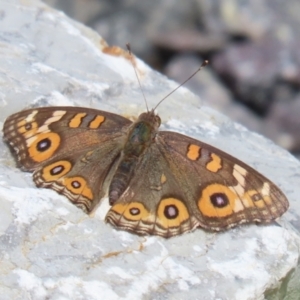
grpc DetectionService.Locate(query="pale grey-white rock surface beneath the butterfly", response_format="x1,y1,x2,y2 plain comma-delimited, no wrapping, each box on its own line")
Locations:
0,0,300,300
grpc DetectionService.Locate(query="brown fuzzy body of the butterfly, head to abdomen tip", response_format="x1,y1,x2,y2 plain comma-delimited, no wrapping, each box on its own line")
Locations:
109,111,160,205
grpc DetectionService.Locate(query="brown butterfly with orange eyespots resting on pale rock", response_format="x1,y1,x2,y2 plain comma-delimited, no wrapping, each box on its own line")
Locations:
3,102,289,238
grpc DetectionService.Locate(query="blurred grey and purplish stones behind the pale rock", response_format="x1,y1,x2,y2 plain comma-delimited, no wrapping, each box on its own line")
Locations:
44,0,300,158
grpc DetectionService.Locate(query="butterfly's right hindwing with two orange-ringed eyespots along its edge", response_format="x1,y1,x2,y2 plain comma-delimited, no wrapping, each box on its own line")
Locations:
106,144,200,237
